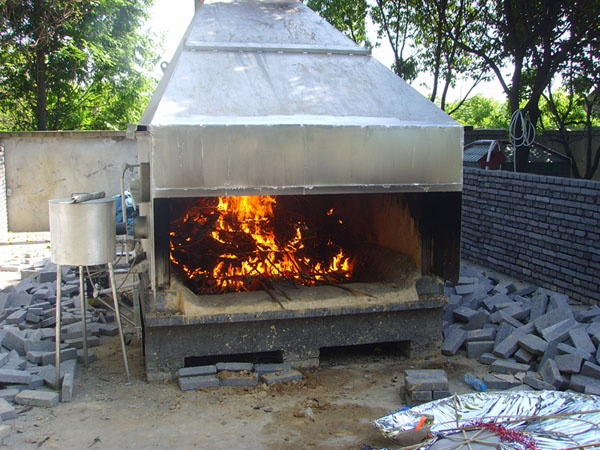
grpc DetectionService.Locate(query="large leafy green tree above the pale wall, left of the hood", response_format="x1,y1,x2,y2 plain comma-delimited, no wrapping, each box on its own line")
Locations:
0,0,157,130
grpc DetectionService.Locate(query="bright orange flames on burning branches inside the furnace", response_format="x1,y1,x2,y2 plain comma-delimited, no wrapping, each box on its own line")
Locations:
170,196,353,293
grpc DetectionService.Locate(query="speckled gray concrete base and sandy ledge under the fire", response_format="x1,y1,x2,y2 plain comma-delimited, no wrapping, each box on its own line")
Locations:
142,279,447,380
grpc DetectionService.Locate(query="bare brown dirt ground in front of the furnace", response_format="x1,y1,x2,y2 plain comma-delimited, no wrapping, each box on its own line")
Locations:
0,232,487,450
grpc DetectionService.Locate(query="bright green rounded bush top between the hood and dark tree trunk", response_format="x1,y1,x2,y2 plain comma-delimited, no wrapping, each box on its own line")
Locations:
447,95,510,129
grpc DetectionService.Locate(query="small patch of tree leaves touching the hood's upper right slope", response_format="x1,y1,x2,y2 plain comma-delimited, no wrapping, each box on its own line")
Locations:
306,0,368,44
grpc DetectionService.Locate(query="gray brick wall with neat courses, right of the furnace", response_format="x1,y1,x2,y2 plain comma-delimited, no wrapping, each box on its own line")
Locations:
461,168,600,302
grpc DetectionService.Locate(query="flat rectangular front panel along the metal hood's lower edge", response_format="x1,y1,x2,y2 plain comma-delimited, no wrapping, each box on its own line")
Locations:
151,125,462,197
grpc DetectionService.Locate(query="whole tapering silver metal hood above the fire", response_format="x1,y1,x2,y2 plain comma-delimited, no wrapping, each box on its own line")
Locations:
140,0,462,198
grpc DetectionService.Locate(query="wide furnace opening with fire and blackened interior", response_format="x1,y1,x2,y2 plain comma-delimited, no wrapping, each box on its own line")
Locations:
169,194,421,295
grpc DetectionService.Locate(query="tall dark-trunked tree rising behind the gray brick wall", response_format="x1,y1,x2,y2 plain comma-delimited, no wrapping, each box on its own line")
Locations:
448,0,600,170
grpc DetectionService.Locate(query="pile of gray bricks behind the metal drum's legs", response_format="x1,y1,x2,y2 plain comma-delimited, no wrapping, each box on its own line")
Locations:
0,261,118,415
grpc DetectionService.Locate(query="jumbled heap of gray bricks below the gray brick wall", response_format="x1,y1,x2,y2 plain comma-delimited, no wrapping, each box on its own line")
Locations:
441,267,600,395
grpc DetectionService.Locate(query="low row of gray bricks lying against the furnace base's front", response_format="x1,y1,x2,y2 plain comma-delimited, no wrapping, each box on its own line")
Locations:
177,362,302,391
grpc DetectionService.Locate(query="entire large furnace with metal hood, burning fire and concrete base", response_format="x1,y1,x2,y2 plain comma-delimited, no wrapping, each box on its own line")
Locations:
130,0,463,379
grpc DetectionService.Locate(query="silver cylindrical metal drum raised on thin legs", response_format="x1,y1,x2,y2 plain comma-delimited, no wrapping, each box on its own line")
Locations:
48,198,116,266
